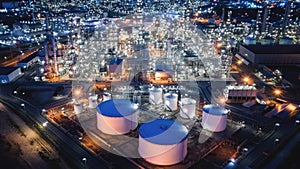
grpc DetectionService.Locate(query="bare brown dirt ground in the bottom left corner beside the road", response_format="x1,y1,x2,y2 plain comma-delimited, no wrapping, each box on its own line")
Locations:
0,103,70,169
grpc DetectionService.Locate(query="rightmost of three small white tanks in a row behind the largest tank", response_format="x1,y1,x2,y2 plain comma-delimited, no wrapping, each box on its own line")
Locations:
179,98,196,118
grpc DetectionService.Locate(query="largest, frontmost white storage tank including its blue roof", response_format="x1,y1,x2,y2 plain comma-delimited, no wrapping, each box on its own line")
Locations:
138,119,188,165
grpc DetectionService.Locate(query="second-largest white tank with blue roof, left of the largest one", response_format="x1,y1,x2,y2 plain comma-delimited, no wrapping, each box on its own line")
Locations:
96,99,138,135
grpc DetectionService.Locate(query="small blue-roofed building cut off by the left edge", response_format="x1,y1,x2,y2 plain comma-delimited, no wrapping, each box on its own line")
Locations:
0,67,21,84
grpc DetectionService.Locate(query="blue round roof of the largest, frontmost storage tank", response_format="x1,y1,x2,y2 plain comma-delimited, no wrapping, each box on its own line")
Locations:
139,119,188,145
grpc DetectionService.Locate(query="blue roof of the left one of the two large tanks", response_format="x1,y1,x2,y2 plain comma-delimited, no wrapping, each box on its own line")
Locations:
97,99,137,117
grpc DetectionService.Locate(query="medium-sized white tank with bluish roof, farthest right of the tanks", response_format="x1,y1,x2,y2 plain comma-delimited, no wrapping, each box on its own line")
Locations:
201,104,228,132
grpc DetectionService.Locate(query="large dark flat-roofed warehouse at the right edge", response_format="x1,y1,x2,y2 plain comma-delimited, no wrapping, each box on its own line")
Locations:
236,44,300,65
